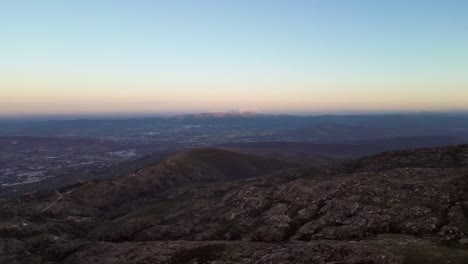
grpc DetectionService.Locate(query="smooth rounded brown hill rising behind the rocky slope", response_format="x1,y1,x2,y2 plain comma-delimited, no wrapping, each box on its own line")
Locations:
50,148,296,212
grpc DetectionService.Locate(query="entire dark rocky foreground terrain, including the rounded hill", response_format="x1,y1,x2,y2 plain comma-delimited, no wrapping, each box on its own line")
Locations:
0,145,468,264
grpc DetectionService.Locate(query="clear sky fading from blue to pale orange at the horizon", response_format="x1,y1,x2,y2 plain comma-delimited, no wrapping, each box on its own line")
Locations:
0,0,468,116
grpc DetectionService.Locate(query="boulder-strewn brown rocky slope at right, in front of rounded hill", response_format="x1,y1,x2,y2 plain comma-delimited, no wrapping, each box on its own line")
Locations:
80,145,468,245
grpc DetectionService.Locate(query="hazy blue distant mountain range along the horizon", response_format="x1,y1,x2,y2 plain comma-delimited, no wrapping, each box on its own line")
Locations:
0,112,468,140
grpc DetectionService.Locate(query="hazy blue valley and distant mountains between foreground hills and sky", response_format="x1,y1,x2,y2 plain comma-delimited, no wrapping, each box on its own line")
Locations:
0,113,468,195
